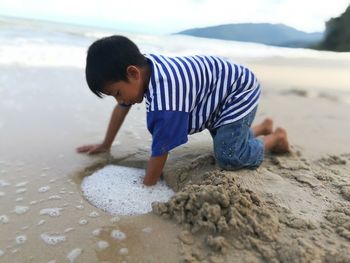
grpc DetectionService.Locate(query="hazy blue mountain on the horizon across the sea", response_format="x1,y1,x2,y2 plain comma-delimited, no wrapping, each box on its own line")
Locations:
177,23,323,47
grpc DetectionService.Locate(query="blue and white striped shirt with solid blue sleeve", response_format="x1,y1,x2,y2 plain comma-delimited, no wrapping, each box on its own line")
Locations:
145,54,261,156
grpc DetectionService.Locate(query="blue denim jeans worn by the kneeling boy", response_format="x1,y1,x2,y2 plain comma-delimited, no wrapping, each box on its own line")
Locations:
210,107,264,170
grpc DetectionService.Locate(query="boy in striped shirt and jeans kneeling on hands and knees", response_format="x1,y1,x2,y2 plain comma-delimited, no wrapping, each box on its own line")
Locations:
77,36,289,185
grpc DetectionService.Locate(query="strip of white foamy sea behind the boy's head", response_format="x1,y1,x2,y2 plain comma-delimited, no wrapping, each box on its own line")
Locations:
0,17,350,68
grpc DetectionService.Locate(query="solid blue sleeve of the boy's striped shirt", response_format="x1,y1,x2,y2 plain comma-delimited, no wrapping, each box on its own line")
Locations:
147,111,189,156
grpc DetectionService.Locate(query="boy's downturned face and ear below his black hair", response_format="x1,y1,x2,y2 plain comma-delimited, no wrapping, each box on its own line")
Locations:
103,66,145,105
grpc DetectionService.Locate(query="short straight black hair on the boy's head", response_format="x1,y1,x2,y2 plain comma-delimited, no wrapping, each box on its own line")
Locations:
85,35,147,98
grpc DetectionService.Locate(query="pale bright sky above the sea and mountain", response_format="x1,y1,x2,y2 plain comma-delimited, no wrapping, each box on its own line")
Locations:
0,0,350,34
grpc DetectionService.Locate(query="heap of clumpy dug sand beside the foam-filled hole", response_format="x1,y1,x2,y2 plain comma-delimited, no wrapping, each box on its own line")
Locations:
152,172,278,241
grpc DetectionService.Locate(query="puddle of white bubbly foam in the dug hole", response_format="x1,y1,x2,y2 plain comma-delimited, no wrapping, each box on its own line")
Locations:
81,165,174,215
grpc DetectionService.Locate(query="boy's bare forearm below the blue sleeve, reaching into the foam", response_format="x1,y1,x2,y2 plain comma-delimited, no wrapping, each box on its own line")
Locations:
143,153,168,186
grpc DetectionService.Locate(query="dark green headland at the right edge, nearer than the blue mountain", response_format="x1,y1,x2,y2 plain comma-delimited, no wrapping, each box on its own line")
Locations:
319,5,350,51
